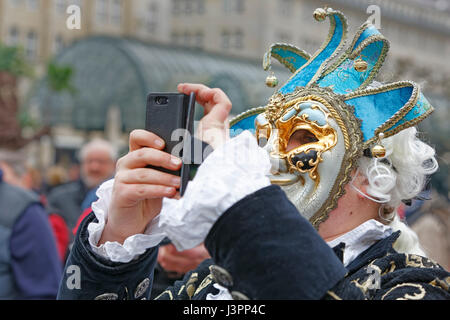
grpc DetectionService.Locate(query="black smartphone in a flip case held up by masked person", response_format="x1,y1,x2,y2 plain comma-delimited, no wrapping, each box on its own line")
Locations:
145,93,195,196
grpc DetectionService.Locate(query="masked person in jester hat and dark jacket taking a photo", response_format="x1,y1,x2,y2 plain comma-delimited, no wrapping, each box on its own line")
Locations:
59,8,450,300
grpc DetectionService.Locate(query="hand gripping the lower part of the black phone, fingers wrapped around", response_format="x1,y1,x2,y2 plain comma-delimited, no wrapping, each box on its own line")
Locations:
98,130,182,245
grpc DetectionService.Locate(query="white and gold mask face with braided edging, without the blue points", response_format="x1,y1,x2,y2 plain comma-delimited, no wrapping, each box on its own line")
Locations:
255,87,362,227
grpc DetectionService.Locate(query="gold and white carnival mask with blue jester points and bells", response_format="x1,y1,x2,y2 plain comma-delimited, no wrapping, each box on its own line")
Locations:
230,8,433,228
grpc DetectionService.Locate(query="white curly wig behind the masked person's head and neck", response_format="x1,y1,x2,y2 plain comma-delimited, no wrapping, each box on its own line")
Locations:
359,127,438,256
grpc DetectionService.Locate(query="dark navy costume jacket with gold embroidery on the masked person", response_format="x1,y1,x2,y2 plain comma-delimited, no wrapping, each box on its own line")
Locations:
58,186,450,300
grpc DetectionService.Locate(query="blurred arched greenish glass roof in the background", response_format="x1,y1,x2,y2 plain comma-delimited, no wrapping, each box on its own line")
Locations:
27,36,289,131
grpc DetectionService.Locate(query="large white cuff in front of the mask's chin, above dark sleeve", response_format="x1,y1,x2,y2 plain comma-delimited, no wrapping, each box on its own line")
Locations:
159,131,271,251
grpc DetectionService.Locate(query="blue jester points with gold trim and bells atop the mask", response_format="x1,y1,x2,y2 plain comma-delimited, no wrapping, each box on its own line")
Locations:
231,8,433,152
